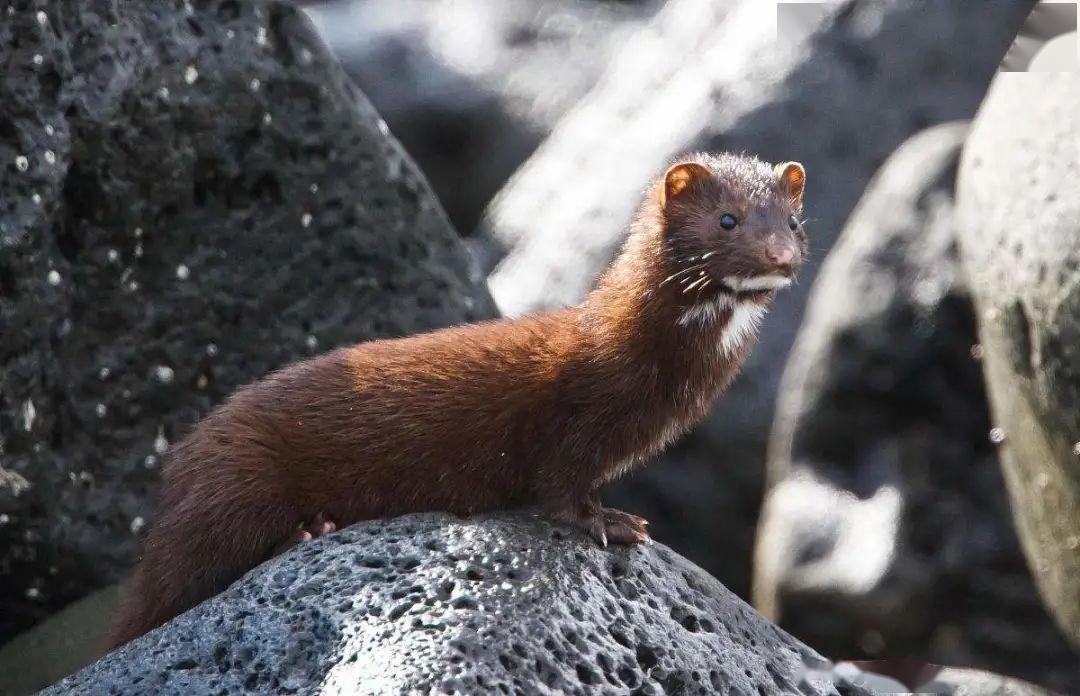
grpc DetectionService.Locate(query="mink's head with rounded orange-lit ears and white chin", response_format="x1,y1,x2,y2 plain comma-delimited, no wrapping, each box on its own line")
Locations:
658,155,807,302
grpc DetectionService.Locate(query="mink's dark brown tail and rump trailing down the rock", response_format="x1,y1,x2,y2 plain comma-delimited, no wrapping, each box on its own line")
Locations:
105,451,300,651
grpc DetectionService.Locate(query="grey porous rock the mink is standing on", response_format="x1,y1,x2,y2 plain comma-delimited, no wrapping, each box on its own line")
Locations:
43,512,866,694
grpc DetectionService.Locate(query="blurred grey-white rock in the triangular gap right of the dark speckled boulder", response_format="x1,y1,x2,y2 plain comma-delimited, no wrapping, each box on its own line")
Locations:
307,0,661,233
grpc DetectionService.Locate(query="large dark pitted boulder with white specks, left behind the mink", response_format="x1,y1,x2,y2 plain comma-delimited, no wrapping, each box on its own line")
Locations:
0,0,492,638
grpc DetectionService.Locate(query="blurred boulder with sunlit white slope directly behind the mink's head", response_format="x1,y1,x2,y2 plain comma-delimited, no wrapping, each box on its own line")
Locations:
477,0,1035,591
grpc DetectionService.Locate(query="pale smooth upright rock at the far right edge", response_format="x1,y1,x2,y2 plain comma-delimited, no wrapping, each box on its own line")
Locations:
958,72,1080,647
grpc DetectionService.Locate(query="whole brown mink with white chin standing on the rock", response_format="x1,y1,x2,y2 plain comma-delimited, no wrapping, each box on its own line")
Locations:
110,155,807,646
